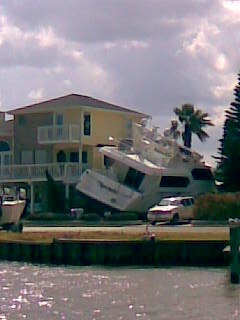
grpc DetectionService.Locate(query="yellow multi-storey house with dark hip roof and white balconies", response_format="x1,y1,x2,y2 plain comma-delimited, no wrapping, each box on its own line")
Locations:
0,94,149,211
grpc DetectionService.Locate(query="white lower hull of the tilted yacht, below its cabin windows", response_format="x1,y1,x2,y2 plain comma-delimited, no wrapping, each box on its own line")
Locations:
76,169,215,212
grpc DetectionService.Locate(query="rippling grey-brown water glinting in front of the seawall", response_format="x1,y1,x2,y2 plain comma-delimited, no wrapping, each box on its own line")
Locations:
0,262,240,320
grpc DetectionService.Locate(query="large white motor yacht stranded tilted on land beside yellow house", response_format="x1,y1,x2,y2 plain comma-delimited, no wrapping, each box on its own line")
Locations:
76,124,215,212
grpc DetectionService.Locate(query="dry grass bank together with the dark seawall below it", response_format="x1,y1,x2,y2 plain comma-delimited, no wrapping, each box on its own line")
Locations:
0,227,229,267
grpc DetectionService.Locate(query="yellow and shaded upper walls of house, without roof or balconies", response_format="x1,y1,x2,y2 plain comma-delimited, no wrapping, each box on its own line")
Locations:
14,107,144,169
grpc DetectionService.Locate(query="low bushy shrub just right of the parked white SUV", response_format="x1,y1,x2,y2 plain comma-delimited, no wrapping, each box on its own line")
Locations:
194,193,240,220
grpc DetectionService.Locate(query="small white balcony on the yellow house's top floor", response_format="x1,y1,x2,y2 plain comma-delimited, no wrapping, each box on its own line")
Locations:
37,124,81,144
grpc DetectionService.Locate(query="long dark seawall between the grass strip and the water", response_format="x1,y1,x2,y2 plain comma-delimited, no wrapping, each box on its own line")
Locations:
0,238,229,266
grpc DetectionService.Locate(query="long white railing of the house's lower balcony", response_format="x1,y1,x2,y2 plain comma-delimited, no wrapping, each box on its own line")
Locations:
0,162,82,182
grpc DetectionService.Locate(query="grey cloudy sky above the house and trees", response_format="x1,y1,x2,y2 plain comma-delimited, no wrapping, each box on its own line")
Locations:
0,0,240,165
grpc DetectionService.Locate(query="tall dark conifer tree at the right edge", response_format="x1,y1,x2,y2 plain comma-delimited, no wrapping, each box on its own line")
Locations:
215,74,240,191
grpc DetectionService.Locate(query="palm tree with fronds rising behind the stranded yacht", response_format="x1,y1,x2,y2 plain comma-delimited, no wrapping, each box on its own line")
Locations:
174,103,214,148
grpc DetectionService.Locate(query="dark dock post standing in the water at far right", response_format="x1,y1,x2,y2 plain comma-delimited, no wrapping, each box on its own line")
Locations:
230,224,240,284
